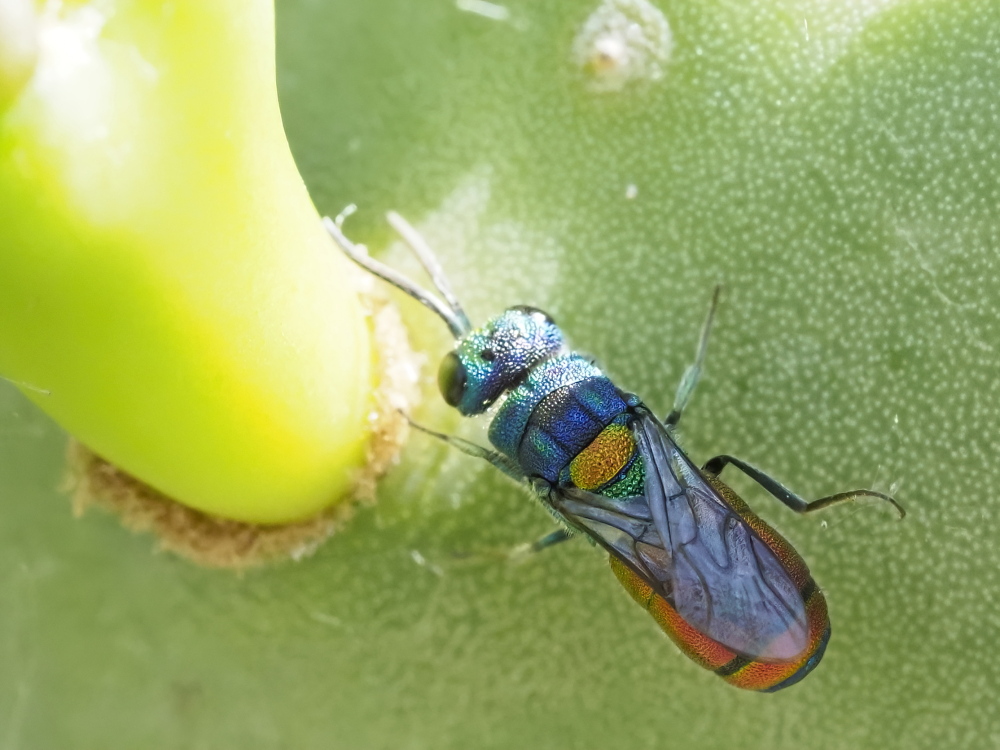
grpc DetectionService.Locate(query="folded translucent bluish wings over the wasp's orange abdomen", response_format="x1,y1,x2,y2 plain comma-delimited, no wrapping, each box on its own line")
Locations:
553,410,809,661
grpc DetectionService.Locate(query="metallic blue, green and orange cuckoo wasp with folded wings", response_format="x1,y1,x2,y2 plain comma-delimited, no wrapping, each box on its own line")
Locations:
324,206,904,692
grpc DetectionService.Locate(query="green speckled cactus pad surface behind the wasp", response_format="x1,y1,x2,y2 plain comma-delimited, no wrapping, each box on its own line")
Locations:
0,0,1000,750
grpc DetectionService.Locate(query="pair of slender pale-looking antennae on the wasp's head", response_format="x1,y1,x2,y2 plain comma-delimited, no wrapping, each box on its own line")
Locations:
323,203,472,339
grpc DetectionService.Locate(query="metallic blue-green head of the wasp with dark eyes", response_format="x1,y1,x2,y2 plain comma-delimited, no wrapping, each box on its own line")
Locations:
438,307,563,415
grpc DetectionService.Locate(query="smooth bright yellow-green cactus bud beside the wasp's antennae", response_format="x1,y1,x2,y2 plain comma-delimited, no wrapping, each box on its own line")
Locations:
0,0,396,536
